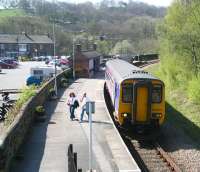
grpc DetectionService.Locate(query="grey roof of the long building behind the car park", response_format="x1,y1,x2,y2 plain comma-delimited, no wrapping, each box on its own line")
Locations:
0,34,53,44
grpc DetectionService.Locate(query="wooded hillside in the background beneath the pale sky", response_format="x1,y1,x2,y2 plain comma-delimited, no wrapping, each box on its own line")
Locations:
0,0,166,54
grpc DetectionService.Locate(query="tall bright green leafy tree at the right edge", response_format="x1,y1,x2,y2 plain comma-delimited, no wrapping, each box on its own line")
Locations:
159,0,200,100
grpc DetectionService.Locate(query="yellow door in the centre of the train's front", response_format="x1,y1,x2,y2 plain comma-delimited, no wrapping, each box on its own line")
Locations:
132,81,151,124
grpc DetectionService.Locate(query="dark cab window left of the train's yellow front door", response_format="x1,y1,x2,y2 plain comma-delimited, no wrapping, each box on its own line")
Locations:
122,84,133,103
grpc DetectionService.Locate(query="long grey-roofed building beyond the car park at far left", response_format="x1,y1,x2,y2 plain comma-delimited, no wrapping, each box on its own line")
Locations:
0,33,53,58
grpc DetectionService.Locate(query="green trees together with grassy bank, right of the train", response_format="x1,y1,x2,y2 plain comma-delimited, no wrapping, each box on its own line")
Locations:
154,0,200,141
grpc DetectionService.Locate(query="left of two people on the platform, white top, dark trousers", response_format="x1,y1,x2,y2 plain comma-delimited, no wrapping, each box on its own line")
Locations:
67,92,78,121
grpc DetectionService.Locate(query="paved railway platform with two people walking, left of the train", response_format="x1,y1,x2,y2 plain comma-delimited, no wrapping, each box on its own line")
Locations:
11,76,140,172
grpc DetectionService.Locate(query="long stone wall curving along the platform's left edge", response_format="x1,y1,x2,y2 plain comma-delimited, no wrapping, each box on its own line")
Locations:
0,70,69,172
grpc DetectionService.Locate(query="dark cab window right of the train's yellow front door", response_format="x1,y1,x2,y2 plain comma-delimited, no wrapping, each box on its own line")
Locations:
152,85,162,103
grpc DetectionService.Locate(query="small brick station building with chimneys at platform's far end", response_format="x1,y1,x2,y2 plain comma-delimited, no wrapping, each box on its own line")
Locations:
74,44,101,78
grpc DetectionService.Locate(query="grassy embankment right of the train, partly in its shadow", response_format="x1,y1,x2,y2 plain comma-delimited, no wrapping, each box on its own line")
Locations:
147,64,200,143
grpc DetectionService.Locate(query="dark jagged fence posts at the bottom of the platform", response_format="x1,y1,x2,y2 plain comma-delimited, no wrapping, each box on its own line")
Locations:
68,144,82,172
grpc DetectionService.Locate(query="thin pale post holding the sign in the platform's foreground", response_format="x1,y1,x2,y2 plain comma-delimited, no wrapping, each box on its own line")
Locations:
89,102,92,172
